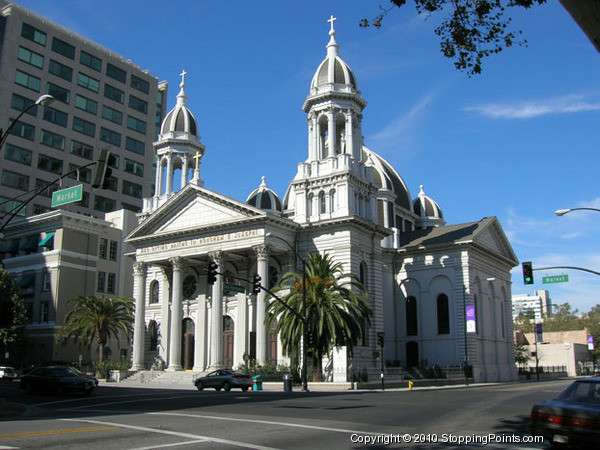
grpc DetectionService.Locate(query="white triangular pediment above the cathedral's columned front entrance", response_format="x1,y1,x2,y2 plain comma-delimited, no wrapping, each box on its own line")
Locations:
127,185,267,240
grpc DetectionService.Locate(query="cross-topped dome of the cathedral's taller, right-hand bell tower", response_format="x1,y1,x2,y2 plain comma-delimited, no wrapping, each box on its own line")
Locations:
310,17,358,94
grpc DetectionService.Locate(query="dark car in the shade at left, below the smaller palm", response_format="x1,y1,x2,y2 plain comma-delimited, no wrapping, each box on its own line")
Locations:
21,366,98,395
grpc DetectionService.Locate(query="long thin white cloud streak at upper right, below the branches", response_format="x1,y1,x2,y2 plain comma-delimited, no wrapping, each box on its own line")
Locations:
464,93,600,119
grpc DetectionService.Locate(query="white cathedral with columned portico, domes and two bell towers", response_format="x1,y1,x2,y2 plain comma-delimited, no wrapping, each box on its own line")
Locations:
126,17,518,382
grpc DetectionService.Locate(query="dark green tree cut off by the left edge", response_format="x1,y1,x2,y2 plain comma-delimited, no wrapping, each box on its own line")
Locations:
0,267,27,359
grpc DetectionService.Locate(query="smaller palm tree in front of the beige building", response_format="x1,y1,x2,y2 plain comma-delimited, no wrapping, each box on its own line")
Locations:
57,296,134,363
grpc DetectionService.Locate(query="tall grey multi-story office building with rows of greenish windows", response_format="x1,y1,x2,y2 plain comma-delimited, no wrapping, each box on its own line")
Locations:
0,0,167,221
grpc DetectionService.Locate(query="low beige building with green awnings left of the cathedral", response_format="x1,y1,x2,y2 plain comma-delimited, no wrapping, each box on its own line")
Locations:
2,210,137,365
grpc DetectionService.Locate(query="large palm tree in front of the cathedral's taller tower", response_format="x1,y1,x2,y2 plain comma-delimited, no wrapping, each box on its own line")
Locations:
267,253,371,381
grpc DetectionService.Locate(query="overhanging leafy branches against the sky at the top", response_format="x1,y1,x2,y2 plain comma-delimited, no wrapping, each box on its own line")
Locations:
359,0,546,76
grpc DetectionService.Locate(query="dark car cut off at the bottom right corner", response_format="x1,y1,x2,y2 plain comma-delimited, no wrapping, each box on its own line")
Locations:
529,378,600,448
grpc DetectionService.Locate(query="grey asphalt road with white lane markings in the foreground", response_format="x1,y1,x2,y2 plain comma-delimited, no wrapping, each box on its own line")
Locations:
0,380,570,450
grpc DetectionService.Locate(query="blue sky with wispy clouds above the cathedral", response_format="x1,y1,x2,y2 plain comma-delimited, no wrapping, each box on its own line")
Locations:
11,0,600,313
